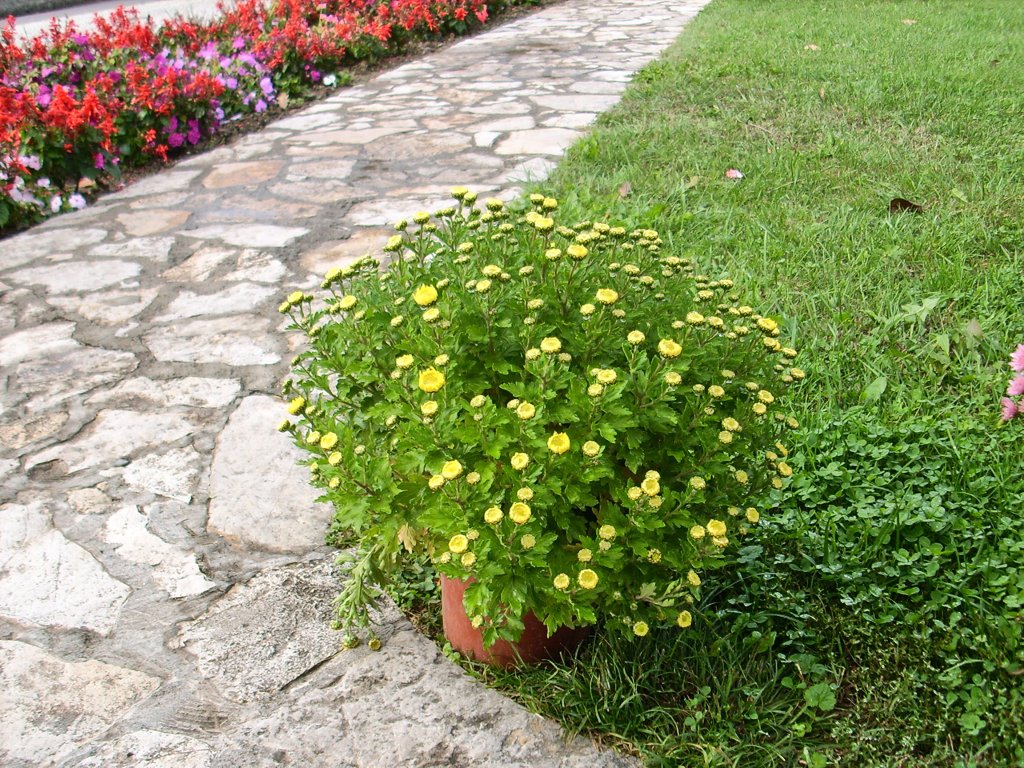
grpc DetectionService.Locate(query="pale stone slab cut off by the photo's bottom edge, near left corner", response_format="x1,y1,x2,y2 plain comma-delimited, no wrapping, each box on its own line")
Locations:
76,729,216,768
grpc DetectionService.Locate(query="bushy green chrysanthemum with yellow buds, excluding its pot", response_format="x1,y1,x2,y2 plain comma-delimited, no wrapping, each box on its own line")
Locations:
281,188,804,663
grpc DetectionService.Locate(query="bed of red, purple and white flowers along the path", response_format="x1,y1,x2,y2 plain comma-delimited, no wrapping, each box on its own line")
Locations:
0,0,526,232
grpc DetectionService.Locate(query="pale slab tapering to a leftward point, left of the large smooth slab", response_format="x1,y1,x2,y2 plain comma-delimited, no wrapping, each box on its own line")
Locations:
26,409,195,474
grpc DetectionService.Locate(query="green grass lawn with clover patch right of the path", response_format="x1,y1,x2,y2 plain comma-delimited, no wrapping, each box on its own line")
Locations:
481,0,1024,768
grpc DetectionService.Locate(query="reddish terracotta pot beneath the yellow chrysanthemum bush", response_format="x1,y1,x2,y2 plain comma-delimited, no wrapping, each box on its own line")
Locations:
441,575,590,667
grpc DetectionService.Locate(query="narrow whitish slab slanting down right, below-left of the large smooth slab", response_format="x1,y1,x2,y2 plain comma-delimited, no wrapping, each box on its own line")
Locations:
103,506,217,598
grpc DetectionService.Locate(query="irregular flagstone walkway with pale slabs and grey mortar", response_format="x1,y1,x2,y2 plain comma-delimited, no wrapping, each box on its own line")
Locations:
0,0,707,768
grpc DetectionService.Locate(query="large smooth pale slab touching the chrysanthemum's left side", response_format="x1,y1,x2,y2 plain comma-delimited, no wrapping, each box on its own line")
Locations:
208,395,332,552
